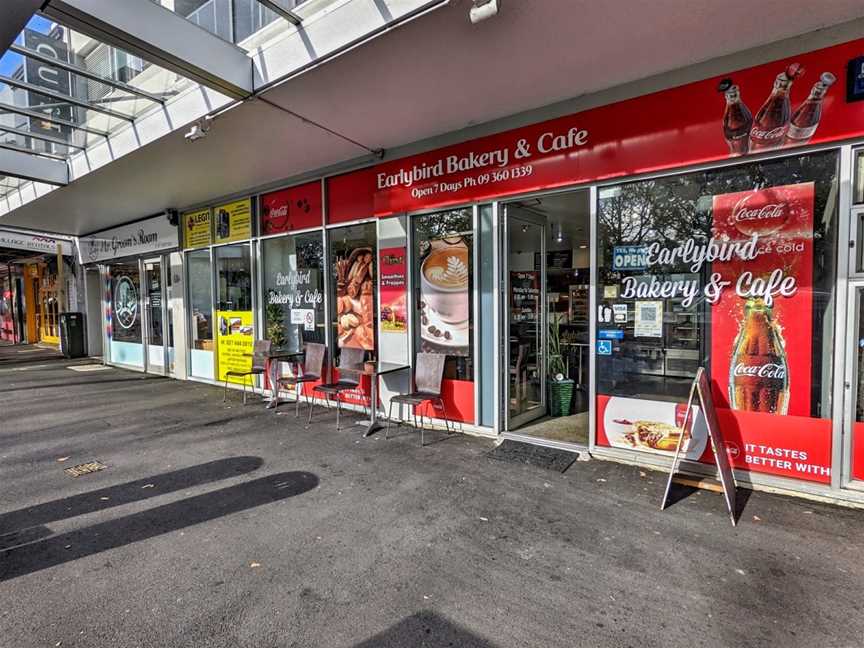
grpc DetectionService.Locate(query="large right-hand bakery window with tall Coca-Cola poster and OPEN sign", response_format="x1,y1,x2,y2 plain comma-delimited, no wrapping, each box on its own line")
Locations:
597,152,838,481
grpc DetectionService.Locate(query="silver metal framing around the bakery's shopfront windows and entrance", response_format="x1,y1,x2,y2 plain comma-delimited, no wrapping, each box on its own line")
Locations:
172,140,856,492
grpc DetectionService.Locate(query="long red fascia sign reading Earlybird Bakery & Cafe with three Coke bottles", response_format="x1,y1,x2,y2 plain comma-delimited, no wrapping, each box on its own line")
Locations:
328,40,864,222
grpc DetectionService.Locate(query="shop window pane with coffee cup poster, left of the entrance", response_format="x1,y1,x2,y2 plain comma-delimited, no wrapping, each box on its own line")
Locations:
413,209,474,381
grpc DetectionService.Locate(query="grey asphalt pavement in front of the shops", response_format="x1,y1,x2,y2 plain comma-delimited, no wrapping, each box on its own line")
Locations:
0,350,864,648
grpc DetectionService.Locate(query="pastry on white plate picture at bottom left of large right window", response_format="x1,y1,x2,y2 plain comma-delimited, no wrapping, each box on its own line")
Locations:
603,396,708,460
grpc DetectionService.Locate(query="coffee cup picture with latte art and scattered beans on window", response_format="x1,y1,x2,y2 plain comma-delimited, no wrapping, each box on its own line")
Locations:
420,238,471,356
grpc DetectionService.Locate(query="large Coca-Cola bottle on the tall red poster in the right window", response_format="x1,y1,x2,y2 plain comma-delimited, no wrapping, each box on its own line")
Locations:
729,298,789,414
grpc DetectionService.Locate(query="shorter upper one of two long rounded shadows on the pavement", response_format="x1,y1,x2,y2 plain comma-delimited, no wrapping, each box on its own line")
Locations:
0,457,264,532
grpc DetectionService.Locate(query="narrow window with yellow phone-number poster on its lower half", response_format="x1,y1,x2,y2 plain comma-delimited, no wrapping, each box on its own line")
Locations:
213,243,255,382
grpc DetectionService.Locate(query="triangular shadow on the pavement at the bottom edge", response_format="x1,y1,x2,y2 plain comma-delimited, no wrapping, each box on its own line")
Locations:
354,610,495,648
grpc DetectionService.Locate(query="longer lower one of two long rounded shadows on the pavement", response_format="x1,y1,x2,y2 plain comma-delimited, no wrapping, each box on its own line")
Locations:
0,471,318,581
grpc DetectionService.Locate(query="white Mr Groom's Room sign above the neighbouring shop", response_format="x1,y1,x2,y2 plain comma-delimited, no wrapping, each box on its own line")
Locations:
78,215,179,263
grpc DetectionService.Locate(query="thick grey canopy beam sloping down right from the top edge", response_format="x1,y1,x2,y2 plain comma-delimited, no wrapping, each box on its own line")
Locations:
40,0,255,99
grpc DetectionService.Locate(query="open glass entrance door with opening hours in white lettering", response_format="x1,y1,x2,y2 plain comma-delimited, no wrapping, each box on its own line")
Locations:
502,209,546,431
